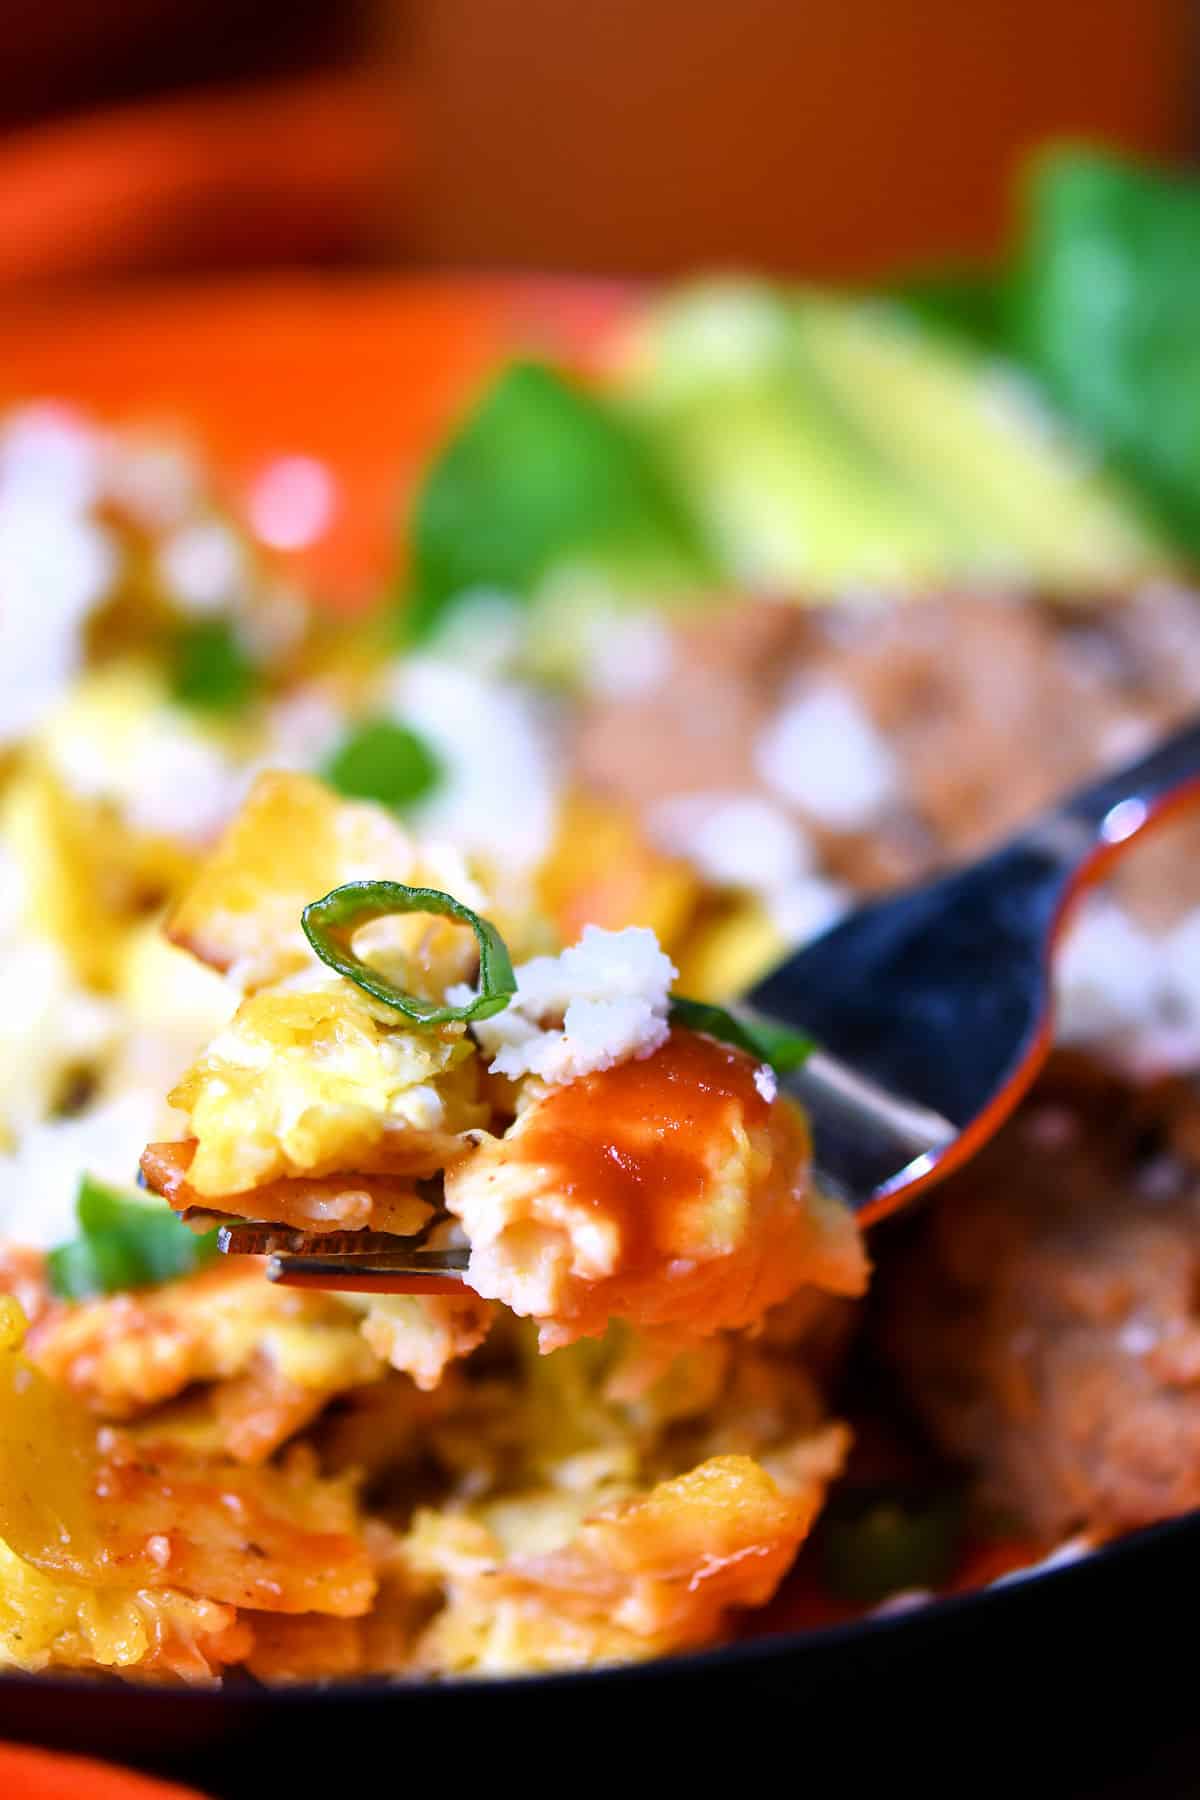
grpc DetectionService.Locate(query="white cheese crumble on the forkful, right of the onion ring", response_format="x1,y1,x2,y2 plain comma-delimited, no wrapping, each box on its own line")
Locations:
453,925,678,1085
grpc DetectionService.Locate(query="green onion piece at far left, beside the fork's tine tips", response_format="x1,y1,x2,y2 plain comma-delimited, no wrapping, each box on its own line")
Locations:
47,1175,216,1300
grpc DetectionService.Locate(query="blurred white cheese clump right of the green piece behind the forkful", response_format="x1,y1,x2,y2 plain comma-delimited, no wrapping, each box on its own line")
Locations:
390,657,560,871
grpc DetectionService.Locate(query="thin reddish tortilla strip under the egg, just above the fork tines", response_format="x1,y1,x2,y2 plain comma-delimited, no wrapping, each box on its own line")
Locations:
142,1138,434,1237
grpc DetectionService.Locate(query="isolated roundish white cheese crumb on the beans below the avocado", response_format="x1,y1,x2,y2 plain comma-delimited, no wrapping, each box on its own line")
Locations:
754,682,900,832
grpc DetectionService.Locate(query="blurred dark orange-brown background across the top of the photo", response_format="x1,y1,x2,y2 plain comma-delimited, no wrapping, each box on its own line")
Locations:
0,0,1196,286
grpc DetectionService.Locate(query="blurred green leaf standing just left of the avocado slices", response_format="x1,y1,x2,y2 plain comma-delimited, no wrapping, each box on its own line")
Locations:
403,362,707,639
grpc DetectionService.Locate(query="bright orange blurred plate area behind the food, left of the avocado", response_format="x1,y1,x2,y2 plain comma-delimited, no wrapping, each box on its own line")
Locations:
0,274,635,605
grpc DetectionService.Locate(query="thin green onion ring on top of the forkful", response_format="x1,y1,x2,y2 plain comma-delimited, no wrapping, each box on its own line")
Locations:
300,882,516,1024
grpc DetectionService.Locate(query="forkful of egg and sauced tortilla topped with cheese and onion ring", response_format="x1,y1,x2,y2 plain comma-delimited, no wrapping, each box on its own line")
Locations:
142,776,865,1355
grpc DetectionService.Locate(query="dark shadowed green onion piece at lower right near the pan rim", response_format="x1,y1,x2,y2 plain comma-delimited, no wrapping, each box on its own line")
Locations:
817,1489,963,1606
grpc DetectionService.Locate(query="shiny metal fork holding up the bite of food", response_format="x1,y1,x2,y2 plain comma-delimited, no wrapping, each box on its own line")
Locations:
219,720,1200,1294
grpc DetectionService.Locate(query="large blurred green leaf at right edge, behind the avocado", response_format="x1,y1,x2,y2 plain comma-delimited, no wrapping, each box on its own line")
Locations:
1011,149,1200,554
